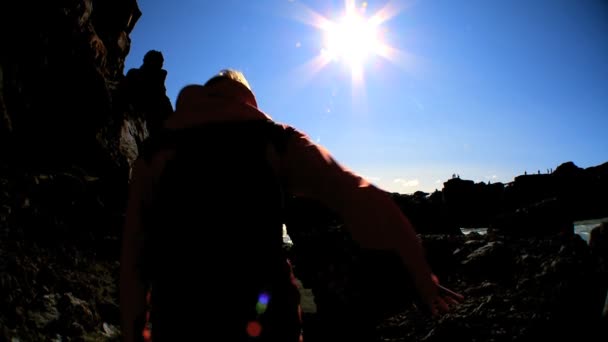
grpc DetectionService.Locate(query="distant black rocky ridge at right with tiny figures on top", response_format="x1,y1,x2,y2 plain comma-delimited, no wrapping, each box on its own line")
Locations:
384,162,608,236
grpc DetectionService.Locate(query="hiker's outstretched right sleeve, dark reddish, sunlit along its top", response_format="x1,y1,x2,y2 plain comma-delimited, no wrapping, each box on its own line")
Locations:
283,132,438,303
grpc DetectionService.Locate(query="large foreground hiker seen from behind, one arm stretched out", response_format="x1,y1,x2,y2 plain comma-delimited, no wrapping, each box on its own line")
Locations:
121,70,461,342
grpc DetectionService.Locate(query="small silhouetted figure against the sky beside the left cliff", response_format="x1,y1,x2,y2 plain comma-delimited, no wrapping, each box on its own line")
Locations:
122,50,173,135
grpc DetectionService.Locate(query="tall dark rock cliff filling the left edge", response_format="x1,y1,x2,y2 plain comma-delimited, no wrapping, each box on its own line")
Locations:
0,0,166,341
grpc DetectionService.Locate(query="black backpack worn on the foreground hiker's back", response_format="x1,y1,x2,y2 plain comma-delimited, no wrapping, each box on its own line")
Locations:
141,120,299,338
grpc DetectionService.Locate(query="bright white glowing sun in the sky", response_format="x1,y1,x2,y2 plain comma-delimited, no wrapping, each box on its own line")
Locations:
323,11,382,70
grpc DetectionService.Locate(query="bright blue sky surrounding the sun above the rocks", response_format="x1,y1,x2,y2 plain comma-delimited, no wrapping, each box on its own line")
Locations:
125,0,608,193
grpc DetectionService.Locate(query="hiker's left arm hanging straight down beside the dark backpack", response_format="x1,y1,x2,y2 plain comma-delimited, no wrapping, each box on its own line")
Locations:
120,160,147,342
